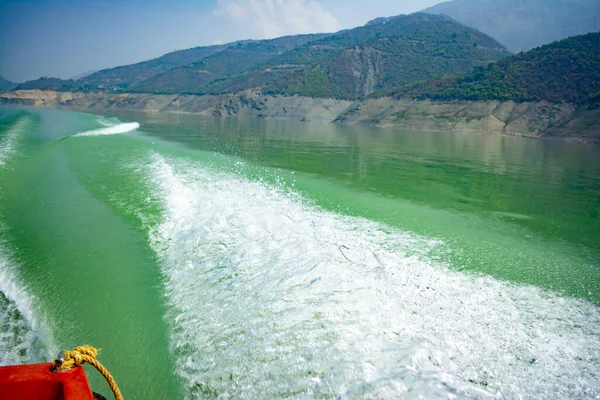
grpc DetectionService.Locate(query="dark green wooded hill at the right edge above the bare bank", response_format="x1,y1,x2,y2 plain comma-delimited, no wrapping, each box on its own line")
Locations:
391,32,600,104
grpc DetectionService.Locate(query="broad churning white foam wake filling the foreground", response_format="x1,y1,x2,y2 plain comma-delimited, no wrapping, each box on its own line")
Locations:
148,155,600,398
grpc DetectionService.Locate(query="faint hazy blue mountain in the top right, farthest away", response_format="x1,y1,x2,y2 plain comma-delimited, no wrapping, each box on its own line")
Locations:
424,0,600,53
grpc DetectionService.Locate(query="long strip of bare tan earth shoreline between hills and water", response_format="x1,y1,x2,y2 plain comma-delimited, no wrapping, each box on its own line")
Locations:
0,90,600,144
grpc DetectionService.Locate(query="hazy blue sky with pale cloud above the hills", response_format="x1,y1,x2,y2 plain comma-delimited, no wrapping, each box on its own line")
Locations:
0,0,442,82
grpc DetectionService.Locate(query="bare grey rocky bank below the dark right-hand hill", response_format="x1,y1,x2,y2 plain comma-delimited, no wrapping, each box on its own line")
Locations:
334,97,600,143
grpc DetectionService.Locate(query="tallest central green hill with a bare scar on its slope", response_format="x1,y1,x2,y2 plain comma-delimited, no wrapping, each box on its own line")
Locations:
195,13,510,99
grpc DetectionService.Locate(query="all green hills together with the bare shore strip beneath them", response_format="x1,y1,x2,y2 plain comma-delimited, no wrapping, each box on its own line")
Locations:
0,13,600,143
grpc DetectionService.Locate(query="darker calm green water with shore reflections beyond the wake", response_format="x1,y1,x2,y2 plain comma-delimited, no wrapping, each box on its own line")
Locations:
123,114,600,245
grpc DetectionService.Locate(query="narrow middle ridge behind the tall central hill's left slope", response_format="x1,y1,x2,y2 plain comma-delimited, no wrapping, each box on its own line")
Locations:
132,34,327,93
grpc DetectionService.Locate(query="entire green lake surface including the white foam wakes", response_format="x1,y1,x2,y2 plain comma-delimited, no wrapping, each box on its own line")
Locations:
0,107,600,399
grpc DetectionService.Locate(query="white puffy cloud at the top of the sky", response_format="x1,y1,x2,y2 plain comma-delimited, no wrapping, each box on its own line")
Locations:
214,0,341,39
